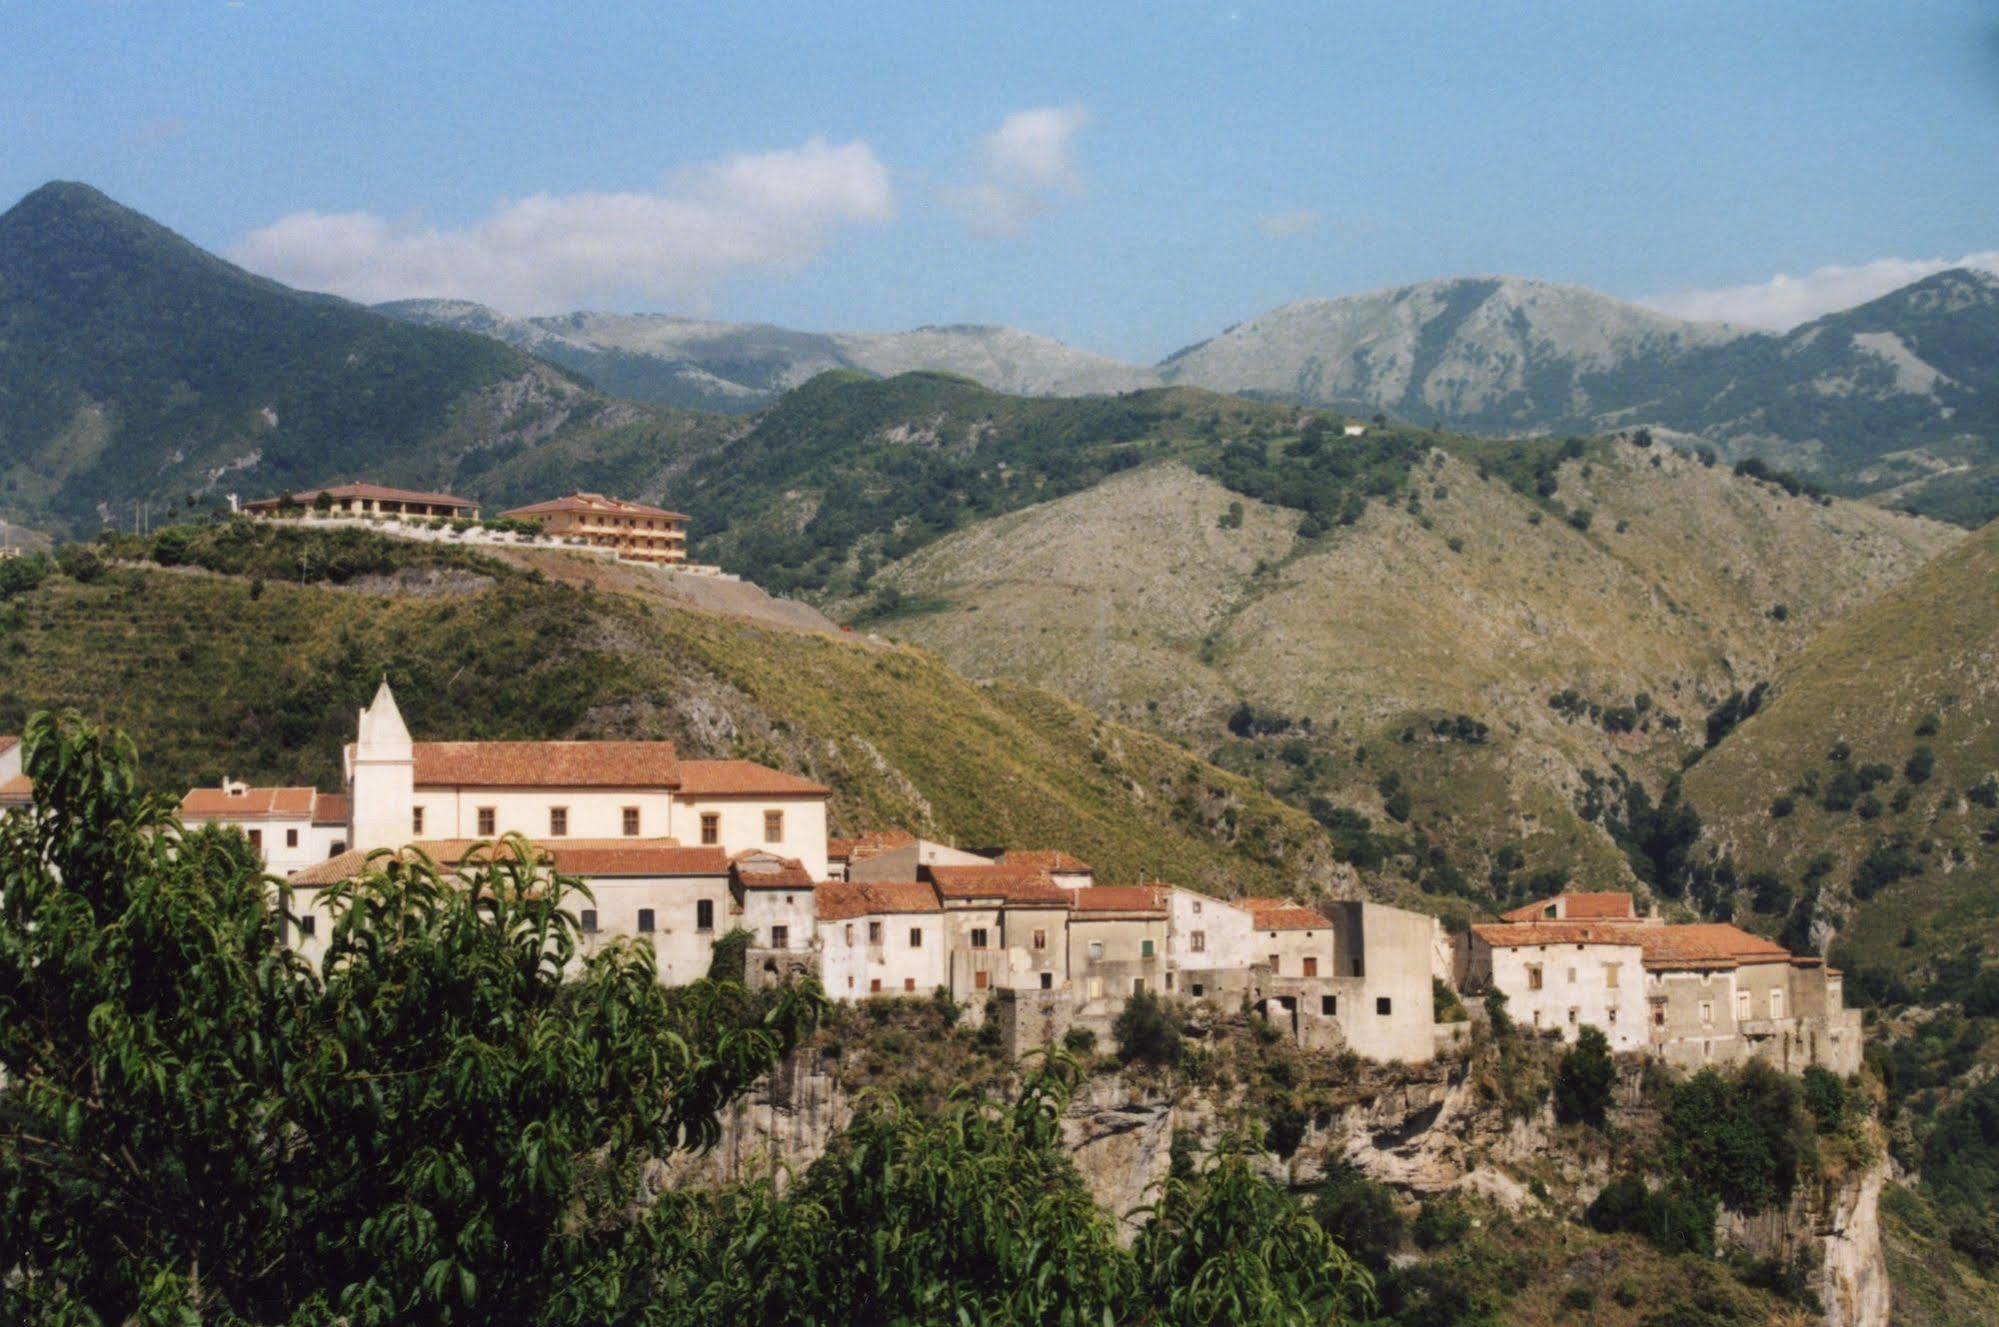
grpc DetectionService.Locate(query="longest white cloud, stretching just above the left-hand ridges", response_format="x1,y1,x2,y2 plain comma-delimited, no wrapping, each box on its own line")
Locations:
230,138,896,314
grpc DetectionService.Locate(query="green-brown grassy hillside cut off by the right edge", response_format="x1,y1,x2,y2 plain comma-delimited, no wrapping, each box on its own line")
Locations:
1687,526,1999,971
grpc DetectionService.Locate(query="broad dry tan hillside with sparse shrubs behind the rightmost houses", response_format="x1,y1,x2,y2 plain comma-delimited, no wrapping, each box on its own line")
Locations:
850,444,1961,883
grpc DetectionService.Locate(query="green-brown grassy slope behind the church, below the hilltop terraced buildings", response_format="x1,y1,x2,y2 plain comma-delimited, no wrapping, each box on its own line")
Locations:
0,532,1341,891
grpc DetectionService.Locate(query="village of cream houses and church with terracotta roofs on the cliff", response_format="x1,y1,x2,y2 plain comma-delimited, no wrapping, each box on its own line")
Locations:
0,681,1861,1073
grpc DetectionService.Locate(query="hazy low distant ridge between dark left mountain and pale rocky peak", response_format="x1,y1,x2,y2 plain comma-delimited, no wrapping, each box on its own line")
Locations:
380,300,1159,410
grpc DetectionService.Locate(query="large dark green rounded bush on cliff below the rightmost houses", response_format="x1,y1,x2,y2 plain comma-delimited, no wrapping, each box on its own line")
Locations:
1663,1061,1817,1213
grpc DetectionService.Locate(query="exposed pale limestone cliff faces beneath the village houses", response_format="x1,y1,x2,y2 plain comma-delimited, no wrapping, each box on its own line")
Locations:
668,1055,1889,1327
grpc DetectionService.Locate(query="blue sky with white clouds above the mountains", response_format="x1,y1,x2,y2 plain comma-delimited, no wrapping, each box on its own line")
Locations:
0,0,1999,362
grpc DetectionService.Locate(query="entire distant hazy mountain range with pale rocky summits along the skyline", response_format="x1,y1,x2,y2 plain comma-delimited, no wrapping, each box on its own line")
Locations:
384,270,1999,524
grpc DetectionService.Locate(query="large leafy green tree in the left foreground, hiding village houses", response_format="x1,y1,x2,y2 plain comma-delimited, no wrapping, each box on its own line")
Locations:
0,713,820,1325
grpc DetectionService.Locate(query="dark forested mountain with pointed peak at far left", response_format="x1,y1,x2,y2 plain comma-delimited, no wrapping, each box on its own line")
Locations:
0,184,727,532
